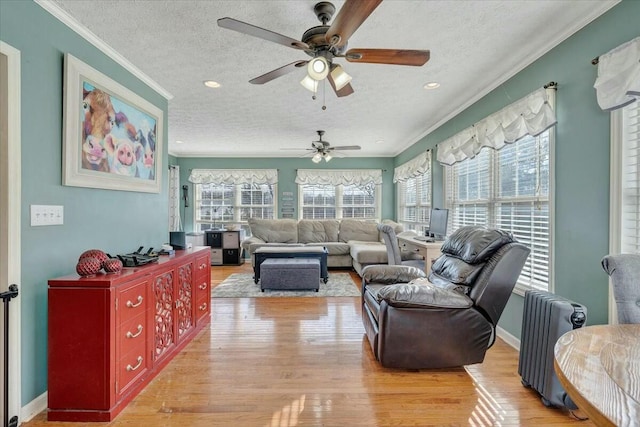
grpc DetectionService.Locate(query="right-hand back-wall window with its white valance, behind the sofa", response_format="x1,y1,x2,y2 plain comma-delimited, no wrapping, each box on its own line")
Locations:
296,170,382,220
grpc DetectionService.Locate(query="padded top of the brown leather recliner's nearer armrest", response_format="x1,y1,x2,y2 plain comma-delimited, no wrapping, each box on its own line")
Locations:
377,282,473,309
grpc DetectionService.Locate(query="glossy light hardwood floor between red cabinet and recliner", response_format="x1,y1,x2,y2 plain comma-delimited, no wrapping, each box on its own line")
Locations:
22,264,593,427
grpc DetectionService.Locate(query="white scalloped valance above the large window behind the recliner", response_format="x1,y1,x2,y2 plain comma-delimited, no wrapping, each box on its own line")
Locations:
437,88,557,166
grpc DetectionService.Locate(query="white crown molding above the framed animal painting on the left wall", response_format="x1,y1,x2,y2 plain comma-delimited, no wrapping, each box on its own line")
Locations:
34,0,173,100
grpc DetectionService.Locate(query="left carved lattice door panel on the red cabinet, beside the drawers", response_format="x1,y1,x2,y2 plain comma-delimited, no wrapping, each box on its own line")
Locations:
153,271,175,360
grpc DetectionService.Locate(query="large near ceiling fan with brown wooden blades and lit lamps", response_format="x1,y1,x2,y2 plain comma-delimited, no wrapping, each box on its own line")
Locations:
218,0,430,97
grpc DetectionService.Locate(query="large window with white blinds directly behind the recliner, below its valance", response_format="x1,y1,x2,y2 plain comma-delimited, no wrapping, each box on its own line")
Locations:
445,130,552,291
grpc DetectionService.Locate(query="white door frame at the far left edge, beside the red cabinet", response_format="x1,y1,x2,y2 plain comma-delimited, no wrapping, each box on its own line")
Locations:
0,41,22,422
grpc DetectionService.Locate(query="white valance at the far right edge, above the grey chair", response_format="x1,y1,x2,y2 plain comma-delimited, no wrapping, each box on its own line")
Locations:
593,37,640,111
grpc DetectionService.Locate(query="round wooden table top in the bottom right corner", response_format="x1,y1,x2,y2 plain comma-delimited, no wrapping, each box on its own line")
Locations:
554,325,640,426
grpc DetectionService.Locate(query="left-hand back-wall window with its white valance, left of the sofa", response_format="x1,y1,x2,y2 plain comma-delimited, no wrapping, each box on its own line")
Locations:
189,169,277,231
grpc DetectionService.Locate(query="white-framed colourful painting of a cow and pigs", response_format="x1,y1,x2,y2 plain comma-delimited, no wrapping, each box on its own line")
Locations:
62,54,163,193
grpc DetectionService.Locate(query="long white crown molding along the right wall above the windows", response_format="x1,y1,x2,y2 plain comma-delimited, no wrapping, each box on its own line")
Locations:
393,0,622,156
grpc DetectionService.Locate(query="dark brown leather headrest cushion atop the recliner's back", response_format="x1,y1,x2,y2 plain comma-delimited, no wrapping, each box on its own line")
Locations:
441,225,515,264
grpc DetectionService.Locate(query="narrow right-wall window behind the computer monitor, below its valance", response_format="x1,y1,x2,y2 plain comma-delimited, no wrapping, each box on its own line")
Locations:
396,171,431,234
